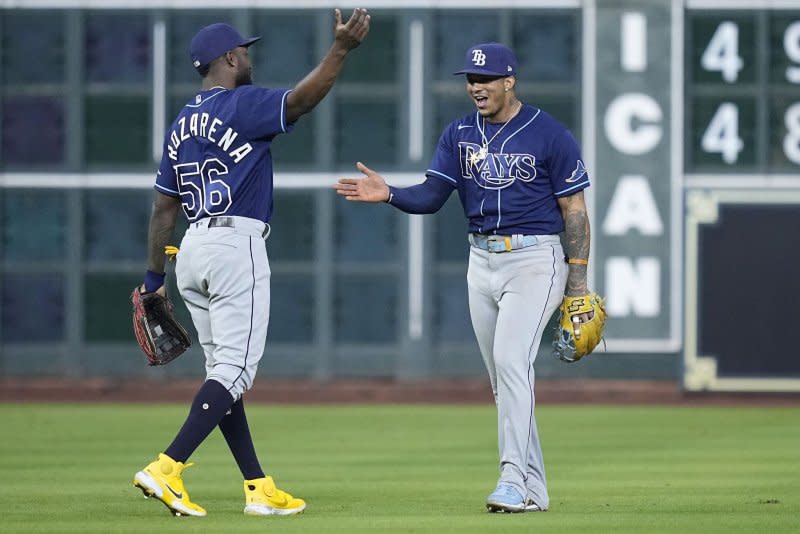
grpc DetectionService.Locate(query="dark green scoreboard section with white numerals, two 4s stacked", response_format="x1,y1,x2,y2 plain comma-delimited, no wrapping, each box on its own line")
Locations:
685,8,800,174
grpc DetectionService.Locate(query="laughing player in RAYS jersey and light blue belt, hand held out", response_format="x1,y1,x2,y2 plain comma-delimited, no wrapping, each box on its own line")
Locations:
334,43,589,512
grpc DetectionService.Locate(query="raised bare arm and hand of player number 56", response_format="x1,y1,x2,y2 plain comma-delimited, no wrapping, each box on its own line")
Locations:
286,8,370,122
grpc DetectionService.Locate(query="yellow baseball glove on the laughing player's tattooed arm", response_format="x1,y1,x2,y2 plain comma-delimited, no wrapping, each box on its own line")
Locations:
553,293,606,362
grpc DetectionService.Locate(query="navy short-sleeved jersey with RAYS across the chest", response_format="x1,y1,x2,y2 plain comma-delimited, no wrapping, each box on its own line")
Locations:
426,105,589,235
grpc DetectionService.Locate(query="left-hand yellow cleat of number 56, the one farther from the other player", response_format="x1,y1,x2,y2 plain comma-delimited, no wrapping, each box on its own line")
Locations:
133,453,206,517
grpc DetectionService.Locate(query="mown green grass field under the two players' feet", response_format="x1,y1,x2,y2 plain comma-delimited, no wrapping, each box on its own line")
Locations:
0,404,800,534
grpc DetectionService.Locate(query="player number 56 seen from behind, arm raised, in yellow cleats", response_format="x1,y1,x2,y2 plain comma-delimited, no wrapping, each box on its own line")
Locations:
133,8,370,516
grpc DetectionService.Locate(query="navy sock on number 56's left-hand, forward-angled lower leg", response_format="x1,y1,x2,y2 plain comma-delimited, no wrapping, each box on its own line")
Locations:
164,380,233,463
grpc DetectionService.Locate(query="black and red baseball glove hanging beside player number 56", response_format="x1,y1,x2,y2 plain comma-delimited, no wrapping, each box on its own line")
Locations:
131,287,192,365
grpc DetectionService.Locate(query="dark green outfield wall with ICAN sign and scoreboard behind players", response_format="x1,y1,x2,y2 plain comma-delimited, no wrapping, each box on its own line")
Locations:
0,0,800,390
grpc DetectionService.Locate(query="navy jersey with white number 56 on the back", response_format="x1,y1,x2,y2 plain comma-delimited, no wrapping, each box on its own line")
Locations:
155,85,293,222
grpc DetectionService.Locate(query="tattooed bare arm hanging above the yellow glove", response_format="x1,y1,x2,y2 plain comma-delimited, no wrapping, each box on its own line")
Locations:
558,191,590,296
